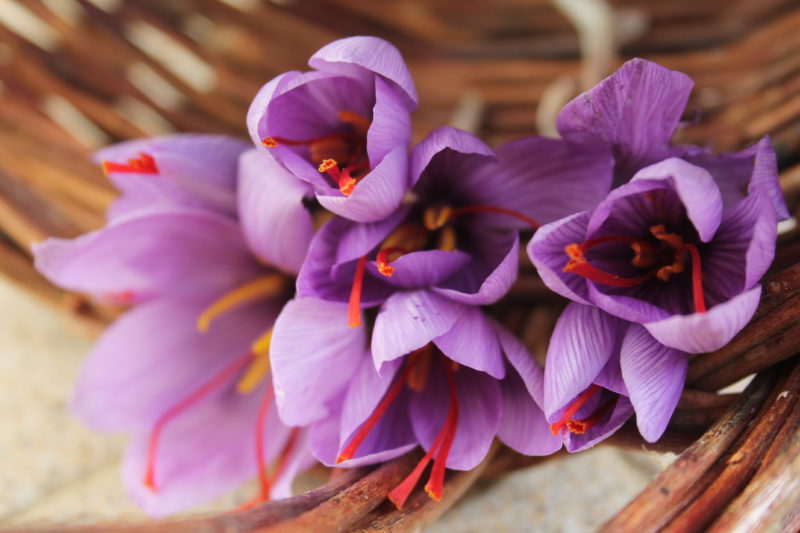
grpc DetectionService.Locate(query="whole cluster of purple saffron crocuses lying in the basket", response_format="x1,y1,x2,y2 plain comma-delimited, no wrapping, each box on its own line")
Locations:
35,37,787,515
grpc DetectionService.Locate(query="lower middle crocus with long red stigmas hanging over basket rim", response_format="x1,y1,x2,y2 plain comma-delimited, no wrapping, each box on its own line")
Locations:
272,298,561,507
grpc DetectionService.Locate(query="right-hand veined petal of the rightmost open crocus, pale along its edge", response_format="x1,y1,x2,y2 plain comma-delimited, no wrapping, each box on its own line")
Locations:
702,190,778,301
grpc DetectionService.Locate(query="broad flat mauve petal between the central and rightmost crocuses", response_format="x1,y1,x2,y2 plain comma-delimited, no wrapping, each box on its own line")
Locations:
462,137,614,227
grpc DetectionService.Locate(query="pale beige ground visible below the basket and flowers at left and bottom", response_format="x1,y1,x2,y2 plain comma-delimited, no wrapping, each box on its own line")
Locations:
0,278,658,533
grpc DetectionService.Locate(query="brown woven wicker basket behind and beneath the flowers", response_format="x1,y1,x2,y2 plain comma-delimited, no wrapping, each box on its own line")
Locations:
0,0,800,532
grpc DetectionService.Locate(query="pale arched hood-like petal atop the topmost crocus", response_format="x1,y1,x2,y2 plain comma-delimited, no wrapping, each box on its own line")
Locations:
308,36,417,111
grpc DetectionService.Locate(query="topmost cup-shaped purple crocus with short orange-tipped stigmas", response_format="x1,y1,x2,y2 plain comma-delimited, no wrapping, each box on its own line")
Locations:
247,37,417,222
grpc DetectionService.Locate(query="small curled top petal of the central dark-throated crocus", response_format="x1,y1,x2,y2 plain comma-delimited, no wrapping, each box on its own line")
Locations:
410,126,494,186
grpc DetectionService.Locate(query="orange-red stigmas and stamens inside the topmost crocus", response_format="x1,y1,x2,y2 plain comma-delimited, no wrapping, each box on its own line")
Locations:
261,109,370,196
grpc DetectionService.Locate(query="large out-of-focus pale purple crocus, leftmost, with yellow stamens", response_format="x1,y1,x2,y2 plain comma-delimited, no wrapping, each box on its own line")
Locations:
34,135,311,516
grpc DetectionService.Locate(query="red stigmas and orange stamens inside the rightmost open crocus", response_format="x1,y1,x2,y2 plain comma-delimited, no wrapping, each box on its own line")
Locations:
563,224,706,313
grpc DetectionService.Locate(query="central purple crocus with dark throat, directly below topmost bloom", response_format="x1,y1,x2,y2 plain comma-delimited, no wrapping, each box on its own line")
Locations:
297,128,611,328
